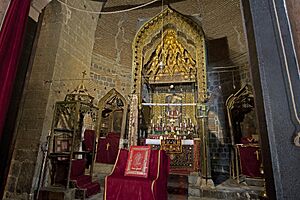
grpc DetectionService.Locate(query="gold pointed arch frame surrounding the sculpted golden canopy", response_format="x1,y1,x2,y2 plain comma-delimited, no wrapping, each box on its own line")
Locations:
132,7,207,102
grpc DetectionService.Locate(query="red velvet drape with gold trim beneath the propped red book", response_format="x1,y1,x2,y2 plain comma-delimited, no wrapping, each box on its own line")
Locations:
104,149,170,200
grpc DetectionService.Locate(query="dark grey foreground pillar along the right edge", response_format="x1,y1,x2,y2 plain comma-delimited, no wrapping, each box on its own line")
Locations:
241,0,300,199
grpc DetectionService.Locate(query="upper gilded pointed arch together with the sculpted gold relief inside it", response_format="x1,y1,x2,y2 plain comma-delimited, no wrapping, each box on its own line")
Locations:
132,7,207,103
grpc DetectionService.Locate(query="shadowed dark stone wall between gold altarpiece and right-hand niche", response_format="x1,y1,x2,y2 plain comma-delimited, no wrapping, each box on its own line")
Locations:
207,66,241,183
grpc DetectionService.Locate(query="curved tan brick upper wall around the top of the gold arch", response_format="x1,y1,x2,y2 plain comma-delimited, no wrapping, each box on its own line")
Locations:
93,0,248,68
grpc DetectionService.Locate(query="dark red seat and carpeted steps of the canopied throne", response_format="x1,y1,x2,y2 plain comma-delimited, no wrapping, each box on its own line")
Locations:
70,159,100,197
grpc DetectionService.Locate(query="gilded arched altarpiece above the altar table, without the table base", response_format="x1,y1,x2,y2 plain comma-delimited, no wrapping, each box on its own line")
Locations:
129,7,207,151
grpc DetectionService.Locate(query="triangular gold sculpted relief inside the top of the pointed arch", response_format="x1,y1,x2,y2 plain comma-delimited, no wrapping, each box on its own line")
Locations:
144,29,196,83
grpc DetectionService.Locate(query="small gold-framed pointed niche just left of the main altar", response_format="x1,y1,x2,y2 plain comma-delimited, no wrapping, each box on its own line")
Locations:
98,88,128,139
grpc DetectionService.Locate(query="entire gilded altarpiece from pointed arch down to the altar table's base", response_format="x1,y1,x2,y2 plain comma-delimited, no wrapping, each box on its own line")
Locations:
129,7,207,171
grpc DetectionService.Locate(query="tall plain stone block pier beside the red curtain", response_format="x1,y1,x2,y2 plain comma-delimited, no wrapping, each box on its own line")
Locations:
4,0,101,199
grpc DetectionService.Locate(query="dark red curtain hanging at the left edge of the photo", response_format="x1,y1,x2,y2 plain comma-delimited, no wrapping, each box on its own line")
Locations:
0,0,31,141
